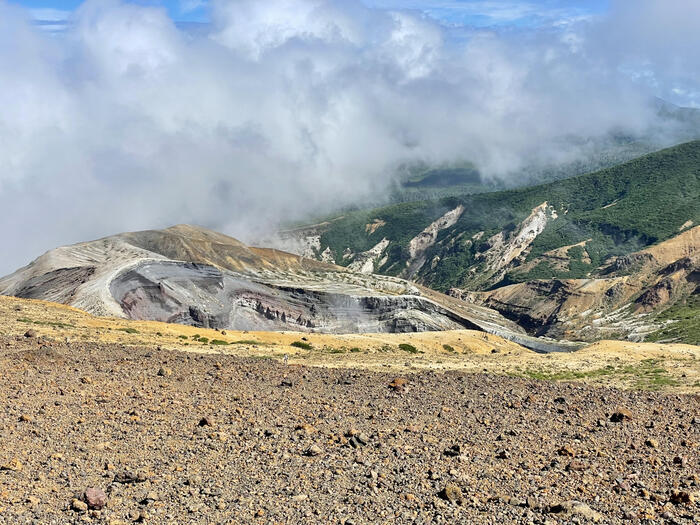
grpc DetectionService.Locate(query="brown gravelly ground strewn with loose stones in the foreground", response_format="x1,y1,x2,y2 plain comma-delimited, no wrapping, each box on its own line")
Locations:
0,333,700,524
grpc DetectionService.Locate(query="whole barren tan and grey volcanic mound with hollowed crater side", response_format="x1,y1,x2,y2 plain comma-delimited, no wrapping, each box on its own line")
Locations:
0,225,566,350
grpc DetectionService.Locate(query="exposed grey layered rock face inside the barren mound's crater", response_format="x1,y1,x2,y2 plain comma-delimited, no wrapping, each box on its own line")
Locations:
110,261,479,333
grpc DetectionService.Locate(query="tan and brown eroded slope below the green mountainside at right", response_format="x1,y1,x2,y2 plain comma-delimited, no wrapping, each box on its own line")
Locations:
450,226,700,342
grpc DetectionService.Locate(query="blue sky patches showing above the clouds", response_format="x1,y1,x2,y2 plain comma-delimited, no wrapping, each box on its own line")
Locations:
15,0,609,27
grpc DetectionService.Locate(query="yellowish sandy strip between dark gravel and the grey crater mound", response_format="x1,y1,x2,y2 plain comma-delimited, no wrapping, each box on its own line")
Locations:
0,297,700,392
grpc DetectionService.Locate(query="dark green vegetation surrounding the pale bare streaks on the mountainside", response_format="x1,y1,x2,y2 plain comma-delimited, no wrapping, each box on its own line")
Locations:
321,141,700,291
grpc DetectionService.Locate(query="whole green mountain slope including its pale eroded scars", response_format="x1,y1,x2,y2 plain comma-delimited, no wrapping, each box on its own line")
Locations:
274,141,700,298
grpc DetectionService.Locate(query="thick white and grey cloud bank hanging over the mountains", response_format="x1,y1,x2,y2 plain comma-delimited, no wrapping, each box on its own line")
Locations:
0,0,700,274
